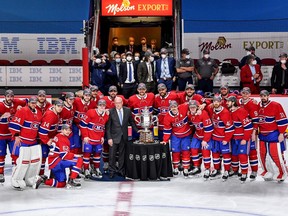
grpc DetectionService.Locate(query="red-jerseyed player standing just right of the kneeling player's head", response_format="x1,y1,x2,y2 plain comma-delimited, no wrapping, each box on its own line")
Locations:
70,89,97,154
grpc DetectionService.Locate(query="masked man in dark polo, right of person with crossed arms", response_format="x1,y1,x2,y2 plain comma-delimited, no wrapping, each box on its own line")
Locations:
195,49,219,92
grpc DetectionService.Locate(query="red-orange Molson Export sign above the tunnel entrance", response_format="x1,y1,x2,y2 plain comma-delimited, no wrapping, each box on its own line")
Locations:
101,0,173,16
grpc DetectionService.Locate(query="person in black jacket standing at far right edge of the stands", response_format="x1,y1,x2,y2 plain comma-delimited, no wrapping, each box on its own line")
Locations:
271,53,288,94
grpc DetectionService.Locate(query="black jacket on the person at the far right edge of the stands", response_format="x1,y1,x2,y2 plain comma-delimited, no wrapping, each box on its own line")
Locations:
271,62,288,91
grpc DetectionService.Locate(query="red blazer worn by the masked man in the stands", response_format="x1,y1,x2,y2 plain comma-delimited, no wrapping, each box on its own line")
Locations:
240,64,263,94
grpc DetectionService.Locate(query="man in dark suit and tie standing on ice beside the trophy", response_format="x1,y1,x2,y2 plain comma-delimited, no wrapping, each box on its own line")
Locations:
106,97,139,178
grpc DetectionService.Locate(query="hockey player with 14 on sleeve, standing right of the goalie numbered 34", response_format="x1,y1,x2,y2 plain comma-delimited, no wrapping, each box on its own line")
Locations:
39,99,63,176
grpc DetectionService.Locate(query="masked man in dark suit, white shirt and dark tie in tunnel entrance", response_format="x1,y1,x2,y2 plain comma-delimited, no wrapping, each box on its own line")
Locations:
119,52,138,99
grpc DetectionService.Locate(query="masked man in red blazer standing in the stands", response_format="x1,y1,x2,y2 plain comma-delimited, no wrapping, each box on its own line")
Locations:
240,55,263,94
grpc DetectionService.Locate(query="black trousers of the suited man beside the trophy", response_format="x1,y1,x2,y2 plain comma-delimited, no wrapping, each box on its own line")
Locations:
109,137,126,176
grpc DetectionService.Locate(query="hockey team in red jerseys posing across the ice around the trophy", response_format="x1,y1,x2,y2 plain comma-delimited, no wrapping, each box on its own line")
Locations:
0,83,288,190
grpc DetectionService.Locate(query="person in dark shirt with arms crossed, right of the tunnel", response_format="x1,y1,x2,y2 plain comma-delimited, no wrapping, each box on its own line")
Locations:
176,48,194,91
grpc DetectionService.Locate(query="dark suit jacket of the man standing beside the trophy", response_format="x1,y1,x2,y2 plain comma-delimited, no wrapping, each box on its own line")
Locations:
106,107,138,143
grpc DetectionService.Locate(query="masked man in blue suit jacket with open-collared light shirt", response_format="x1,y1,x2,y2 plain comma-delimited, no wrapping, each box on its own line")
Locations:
156,48,176,91
